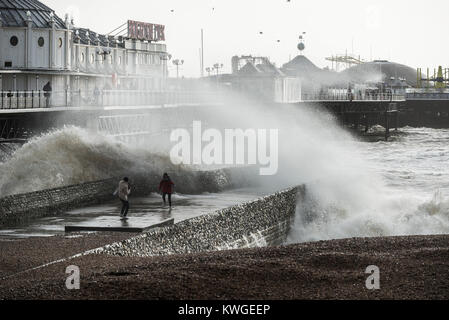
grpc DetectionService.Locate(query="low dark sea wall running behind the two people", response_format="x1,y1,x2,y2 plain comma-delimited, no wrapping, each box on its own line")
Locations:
0,168,254,227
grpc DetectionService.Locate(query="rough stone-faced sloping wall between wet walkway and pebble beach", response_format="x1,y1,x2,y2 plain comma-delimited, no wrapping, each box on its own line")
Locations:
96,186,305,257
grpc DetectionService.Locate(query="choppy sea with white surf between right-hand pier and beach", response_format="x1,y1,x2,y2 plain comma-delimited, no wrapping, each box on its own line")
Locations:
289,128,449,243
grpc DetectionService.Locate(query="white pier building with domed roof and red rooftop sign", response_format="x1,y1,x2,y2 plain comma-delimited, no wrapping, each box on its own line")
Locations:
0,0,168,99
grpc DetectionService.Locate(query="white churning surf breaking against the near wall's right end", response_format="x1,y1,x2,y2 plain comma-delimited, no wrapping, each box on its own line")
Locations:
288,170,449,243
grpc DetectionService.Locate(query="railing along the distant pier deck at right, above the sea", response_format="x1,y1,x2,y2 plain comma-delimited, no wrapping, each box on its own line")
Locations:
302,93,405,101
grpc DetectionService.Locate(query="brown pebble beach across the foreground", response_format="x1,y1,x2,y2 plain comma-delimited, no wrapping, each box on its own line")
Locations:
0,235,449,300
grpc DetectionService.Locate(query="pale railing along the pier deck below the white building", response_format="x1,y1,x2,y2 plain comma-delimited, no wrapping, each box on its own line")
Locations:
0,90,221,110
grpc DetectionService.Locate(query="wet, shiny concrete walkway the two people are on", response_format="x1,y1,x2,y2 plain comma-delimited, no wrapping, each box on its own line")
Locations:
0,189,265,240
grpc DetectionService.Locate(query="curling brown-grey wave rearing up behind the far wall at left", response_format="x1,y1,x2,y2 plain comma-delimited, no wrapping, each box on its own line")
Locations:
0,127,179,197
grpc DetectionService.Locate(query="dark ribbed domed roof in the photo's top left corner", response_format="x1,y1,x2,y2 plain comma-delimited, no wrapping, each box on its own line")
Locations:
0,0,66,29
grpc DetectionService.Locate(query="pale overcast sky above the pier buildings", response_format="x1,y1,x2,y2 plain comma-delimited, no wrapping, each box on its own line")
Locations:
41,0,449,77
